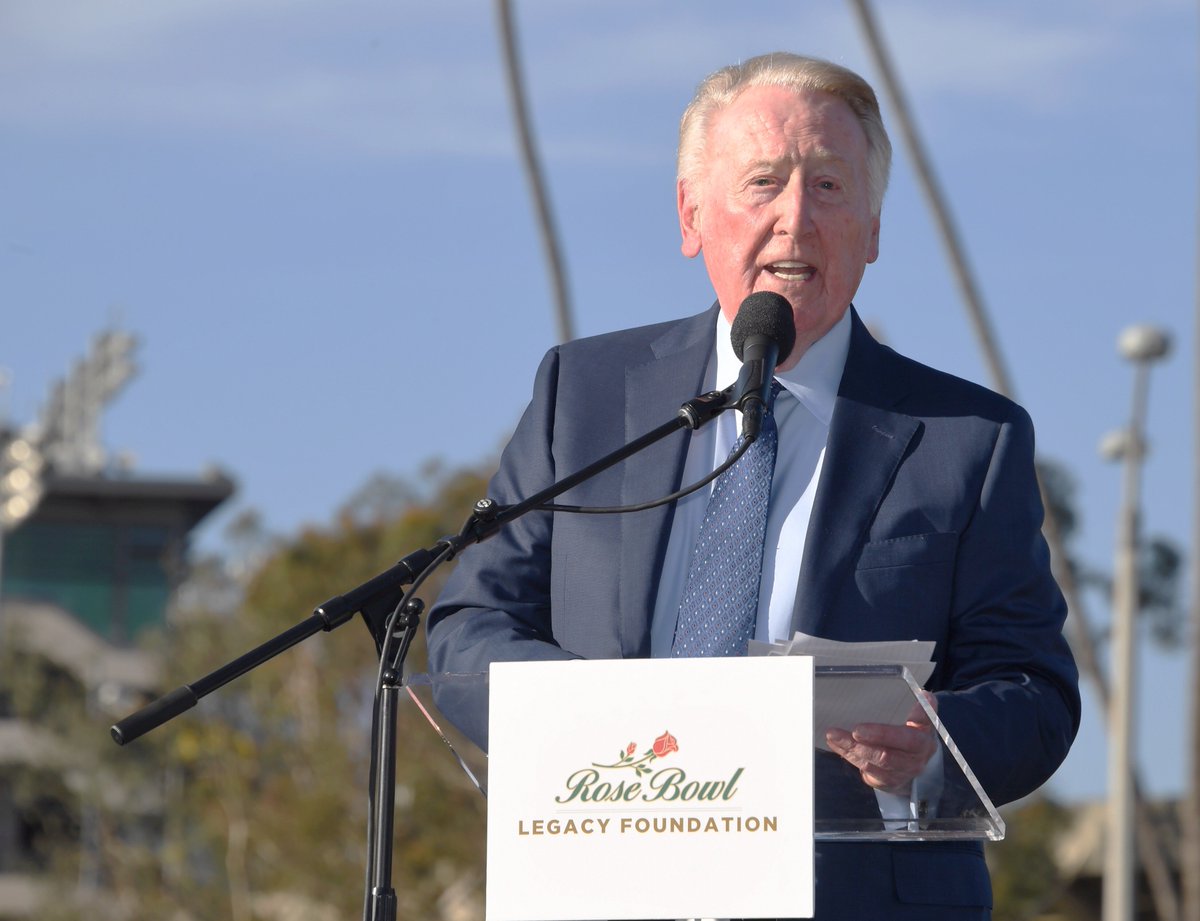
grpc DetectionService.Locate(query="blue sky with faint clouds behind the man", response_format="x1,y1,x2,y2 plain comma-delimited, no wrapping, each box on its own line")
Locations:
0,0,1198,796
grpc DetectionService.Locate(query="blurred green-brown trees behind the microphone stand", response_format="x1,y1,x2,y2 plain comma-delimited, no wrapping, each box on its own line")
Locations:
14,471,486,921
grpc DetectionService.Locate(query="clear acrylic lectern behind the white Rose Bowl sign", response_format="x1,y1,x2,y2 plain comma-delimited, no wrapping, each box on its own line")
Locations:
404,666,1004,841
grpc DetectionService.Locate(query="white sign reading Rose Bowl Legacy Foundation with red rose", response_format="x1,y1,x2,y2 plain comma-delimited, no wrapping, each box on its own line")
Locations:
487,657,814,921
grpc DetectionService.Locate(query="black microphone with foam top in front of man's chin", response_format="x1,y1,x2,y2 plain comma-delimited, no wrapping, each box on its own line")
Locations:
730,291,796,440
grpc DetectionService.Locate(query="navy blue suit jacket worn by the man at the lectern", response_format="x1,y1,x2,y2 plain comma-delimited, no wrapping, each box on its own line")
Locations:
428,307,1080,919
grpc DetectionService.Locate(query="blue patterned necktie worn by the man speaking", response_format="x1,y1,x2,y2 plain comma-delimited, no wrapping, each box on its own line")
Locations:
671,380,780,658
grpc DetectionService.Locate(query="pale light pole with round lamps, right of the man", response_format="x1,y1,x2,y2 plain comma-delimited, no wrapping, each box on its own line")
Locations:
1100,326,1171,921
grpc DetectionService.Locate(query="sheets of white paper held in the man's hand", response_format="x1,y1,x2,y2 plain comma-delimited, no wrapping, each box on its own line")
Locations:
749,632,935,751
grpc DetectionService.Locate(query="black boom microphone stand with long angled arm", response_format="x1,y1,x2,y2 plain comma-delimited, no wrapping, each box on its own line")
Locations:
109,385,752,921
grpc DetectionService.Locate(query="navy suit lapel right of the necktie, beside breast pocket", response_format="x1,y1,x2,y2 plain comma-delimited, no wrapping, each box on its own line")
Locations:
792,313,920,636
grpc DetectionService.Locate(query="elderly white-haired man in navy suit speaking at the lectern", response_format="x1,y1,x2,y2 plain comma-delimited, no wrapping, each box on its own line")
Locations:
428,54,1079,921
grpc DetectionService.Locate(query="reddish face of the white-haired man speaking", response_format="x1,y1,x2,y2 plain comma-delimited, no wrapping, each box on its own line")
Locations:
678,86,880,369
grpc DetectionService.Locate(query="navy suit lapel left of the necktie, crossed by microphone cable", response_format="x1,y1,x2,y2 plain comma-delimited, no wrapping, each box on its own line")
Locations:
619,306,716,656
